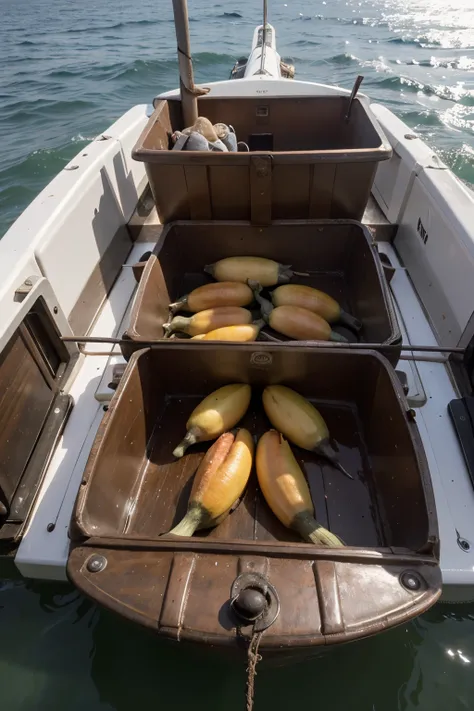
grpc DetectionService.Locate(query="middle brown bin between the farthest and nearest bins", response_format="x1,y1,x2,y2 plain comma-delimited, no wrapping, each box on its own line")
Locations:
125,220,401,364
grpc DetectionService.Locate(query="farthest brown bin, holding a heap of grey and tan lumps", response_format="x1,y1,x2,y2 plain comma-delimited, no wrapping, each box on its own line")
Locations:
132,96,392,224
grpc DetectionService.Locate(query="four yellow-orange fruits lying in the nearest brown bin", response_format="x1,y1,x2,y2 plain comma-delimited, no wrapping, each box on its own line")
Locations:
171,383,352,546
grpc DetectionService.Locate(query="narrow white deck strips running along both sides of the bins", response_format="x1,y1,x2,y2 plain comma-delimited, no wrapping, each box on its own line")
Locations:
15,193,474,601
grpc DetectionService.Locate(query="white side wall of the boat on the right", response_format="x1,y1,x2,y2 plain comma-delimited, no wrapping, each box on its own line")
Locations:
372,105,474,346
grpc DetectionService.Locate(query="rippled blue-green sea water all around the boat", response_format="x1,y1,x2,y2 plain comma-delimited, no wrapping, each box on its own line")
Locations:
0,0,474,711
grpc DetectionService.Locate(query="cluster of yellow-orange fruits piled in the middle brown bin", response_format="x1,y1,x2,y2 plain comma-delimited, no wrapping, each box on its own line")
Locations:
164,257,361,342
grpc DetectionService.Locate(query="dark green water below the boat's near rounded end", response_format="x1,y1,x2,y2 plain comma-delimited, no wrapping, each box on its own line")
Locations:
0,582,474,711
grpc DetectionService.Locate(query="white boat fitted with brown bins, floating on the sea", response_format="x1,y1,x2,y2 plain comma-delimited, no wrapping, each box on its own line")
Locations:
0,0,474,656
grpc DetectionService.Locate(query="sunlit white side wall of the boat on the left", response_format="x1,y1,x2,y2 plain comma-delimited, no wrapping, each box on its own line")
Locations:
0,104,148,336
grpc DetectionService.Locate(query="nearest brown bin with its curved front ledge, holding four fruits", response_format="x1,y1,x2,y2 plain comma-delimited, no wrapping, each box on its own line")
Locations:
68,343,441,648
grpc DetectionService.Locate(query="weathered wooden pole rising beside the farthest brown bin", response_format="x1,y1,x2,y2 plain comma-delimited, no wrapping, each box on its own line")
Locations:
173,0,199,127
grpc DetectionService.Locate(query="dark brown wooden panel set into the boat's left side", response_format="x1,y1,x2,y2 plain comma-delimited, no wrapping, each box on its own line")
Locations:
0,297,73,544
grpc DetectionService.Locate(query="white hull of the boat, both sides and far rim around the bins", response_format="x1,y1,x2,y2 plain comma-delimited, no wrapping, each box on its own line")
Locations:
0,32,474,602
